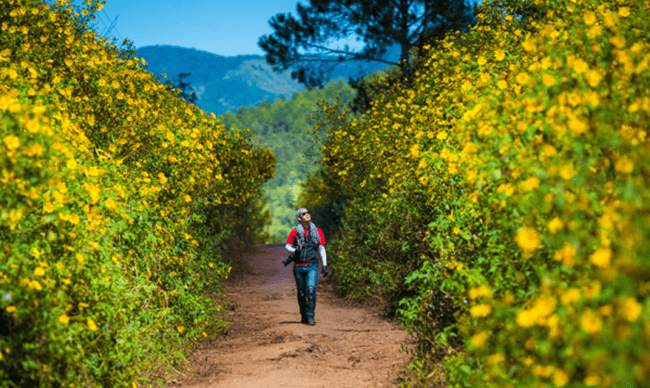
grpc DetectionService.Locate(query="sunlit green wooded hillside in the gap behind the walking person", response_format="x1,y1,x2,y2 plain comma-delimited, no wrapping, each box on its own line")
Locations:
222,79,353,243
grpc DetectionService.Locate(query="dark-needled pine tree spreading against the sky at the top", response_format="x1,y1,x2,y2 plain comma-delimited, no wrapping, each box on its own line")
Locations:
258,0,473,87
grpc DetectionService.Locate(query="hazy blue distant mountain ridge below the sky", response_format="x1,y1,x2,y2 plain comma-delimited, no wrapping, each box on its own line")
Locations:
136,46,399,116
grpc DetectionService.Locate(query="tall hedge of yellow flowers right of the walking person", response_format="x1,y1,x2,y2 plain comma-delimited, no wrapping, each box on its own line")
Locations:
303,0,650,387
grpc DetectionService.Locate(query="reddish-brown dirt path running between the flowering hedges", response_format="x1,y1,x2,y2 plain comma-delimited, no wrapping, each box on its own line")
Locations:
175,245,408,388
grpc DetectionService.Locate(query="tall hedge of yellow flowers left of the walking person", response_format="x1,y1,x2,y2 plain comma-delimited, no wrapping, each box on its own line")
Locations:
0,0,275,387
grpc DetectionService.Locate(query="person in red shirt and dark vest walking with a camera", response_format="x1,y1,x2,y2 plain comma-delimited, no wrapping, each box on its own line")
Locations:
282,208,328,325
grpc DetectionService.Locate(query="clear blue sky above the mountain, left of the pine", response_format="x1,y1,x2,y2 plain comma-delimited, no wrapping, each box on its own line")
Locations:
91,0,362,56
